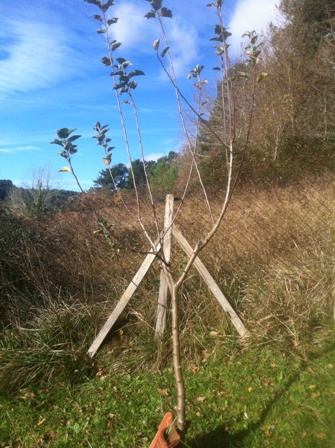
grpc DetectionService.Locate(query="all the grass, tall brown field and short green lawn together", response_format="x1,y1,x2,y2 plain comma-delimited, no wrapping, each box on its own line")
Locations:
0,175,335,448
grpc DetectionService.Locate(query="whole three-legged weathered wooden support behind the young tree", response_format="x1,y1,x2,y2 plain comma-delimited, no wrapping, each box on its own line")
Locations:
87,195,248,358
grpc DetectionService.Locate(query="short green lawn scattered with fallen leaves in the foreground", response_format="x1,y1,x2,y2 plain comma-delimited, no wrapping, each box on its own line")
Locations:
0,343,335,448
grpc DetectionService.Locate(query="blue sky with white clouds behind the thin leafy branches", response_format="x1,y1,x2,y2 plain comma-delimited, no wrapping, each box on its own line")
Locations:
0,0,278,189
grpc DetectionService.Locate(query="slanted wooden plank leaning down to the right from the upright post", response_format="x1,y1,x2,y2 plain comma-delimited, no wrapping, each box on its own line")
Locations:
172,225,248,337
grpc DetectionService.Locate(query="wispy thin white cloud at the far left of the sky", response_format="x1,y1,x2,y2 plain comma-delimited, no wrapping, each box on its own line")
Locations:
0,20,88,99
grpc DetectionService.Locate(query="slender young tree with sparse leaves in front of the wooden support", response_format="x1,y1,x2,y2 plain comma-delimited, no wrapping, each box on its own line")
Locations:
53,0,259,436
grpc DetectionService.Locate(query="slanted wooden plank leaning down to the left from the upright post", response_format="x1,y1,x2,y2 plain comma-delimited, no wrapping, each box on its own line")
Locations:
87,243,161,358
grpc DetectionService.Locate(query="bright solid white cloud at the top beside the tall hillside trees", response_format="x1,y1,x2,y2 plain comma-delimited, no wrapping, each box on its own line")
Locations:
229,0,279,58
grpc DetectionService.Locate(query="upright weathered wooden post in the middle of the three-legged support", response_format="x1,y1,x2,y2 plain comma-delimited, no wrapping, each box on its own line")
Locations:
156,194,174,337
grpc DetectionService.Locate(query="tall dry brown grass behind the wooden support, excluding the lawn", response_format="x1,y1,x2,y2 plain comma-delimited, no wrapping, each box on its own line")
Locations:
0,177,335,387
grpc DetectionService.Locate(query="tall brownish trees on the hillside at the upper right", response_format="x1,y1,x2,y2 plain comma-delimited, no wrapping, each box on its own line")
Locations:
199,0,335,182
